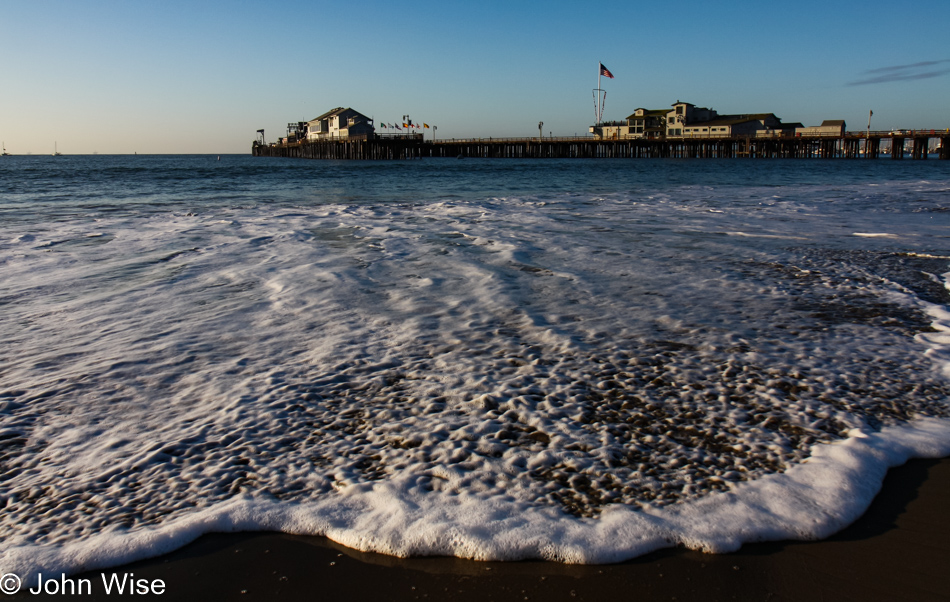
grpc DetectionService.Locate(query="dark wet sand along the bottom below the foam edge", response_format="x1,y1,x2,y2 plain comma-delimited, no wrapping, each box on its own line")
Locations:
22,459,950,602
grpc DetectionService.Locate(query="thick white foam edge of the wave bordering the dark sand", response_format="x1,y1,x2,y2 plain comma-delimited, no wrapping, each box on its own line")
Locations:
0,419,950,574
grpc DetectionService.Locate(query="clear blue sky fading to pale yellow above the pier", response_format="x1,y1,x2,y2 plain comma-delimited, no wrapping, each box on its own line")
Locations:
0,0,950,154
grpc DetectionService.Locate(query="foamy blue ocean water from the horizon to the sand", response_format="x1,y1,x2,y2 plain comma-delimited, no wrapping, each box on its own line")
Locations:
0,156,950,582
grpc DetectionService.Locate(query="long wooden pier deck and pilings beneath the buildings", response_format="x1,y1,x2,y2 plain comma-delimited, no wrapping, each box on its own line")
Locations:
251,130,950,160
